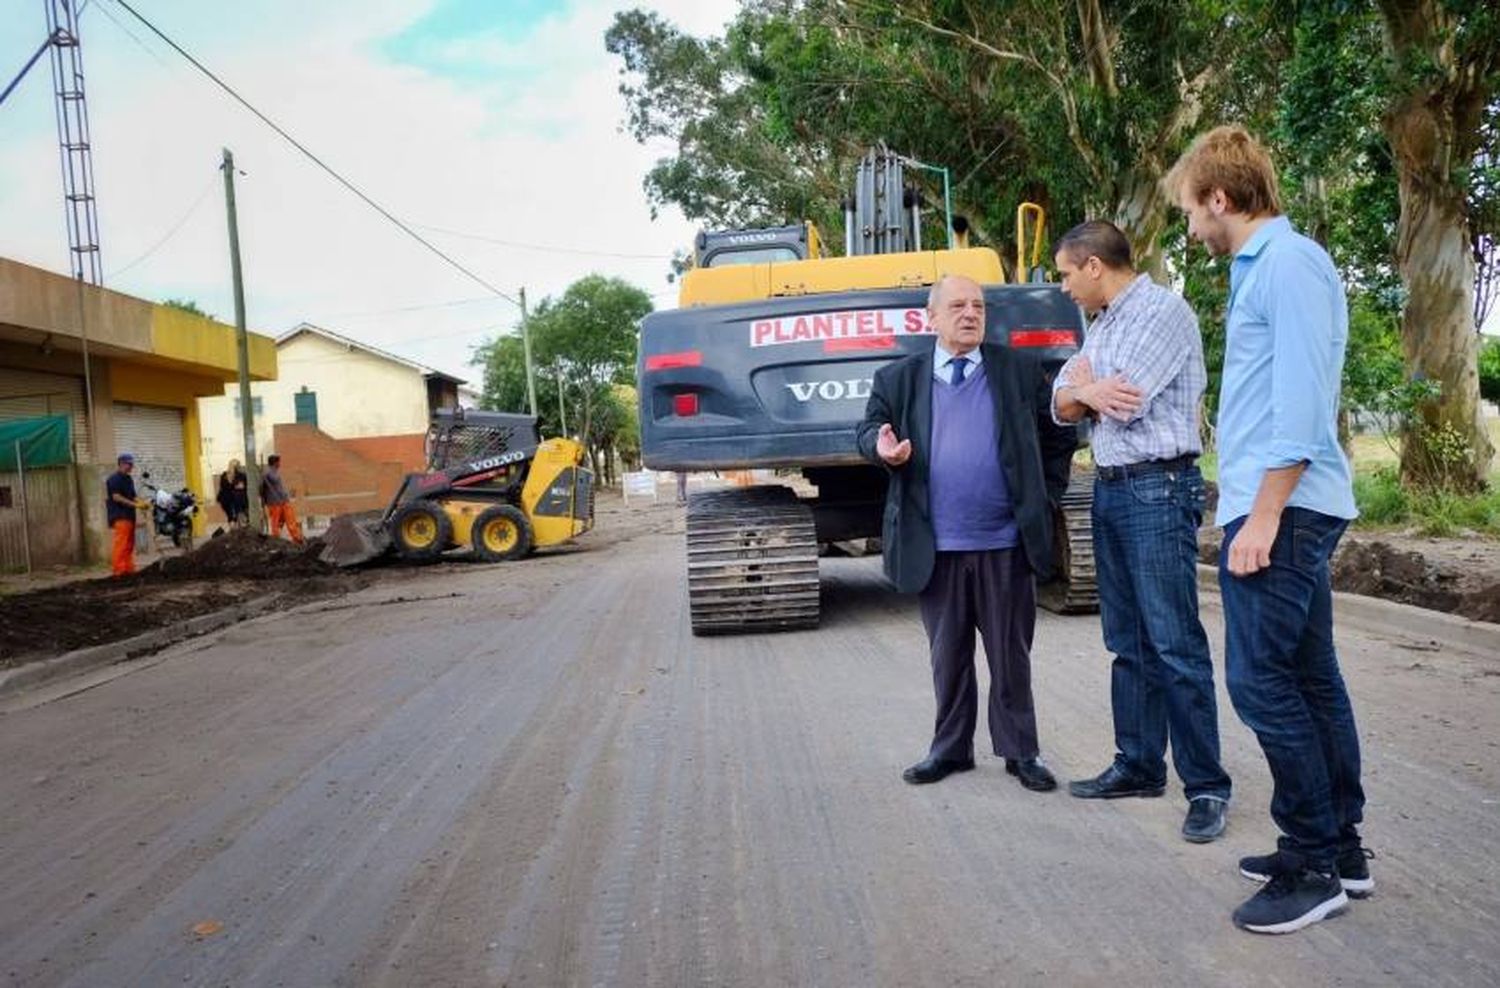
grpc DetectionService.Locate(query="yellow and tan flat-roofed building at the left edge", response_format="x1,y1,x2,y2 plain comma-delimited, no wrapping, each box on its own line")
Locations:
0,258,276,570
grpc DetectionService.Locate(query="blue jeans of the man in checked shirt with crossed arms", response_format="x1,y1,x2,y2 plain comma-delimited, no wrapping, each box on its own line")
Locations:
1094,466,1230,799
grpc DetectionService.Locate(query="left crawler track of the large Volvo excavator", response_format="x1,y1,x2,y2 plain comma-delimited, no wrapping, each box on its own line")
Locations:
687,486,819,634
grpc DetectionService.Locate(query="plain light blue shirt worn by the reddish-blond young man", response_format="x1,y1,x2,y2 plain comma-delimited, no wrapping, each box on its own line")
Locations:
1214,216,1359,525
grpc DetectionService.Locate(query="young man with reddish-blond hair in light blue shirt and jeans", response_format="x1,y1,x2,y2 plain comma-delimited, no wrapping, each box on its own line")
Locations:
1166,126,1374,933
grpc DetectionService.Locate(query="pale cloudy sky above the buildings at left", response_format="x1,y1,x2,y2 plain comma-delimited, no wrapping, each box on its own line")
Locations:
0,0,738,387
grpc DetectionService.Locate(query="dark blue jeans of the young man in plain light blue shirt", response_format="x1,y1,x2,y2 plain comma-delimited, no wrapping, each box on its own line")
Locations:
1220,508,1365,871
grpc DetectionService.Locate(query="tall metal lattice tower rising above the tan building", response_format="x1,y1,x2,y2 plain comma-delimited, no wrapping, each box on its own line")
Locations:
44,0,104,285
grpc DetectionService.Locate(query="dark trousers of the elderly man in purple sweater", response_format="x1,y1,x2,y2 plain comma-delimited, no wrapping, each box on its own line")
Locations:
918,549,1038,759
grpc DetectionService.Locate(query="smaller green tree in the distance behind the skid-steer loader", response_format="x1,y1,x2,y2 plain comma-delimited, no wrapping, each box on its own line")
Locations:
473,274,651,481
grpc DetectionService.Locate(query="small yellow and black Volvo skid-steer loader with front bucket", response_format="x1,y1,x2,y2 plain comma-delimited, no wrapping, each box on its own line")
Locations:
318,409,594,567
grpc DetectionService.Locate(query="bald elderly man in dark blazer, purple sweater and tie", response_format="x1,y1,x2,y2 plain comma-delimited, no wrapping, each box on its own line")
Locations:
858,276,1077,792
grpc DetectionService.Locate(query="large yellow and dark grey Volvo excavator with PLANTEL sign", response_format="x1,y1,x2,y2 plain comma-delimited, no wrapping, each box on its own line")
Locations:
636,147,1098,634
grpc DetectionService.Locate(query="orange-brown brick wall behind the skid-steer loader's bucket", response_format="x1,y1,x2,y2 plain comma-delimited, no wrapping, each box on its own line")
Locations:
273,424,425,520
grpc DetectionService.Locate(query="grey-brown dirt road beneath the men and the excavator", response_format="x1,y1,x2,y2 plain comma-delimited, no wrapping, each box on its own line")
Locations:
0,497,1500,988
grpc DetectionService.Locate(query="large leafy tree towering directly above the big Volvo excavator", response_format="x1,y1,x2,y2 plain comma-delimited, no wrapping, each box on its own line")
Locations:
608,0,1278,275
